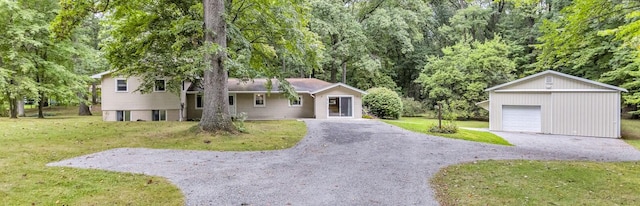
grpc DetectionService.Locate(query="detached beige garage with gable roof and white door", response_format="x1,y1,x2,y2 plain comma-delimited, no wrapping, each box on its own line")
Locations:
477,70,627,138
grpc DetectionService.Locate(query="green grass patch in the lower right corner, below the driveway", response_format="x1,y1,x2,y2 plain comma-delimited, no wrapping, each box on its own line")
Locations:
431,160,640,205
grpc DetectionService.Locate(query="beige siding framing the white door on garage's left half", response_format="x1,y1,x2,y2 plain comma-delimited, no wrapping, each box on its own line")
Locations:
489,92,552,133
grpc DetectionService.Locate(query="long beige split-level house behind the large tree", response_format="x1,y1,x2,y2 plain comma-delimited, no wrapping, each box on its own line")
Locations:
92,72,366,121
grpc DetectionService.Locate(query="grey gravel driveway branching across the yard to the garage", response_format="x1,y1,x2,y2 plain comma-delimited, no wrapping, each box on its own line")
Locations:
48,120,640,205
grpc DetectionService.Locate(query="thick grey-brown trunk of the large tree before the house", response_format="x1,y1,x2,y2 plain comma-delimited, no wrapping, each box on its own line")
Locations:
199,0,235,132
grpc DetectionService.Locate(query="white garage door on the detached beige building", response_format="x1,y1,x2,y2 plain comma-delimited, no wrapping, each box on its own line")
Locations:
502,105,542,132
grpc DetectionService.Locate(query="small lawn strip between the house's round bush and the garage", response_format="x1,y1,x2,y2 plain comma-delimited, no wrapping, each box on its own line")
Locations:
382,117,511,145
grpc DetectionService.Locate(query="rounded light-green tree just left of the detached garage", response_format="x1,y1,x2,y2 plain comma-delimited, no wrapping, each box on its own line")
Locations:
416,38,515,118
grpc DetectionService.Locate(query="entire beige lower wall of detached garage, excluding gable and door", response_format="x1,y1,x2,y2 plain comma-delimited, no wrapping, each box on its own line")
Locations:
489,92,620,137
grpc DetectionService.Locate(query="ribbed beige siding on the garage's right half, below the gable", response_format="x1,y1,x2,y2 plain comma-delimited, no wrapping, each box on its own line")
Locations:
551,92,620,137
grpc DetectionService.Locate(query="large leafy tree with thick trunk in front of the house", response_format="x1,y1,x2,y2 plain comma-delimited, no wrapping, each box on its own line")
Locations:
53,0,322,132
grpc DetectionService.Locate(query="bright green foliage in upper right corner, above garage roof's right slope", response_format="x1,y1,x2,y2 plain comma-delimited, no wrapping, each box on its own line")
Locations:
536,0,640,111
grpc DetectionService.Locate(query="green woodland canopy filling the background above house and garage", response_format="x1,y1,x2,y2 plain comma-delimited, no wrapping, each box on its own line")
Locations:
0,0,640,118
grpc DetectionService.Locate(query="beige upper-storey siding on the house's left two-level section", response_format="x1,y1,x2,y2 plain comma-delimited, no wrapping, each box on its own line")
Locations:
102,75,180,111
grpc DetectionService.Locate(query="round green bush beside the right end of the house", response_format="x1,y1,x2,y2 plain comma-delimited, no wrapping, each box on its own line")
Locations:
362,87,402,119
